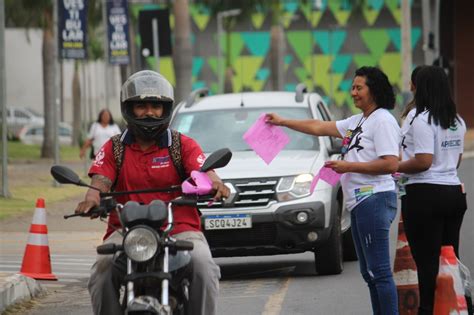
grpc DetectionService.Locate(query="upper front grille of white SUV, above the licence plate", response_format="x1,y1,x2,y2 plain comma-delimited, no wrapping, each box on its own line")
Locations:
198,177,279,209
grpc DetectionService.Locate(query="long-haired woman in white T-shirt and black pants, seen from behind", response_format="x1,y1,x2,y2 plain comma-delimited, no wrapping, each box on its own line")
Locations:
398,66,467,315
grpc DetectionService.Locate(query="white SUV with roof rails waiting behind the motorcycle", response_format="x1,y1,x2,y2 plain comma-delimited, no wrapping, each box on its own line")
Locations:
171,85,357,274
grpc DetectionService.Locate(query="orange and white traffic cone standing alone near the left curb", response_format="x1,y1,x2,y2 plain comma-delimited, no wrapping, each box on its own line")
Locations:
20,198,58,280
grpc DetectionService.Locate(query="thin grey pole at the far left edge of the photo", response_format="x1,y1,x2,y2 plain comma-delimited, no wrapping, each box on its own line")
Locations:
0,0,11,198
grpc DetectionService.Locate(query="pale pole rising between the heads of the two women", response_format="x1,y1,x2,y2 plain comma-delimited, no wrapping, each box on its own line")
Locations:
400,0,412,105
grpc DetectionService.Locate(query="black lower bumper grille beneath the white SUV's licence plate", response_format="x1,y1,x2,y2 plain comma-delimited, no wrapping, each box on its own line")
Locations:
204,223,277,248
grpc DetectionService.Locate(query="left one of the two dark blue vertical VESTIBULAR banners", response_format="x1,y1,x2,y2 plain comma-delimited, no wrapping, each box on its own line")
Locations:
58,0,87,59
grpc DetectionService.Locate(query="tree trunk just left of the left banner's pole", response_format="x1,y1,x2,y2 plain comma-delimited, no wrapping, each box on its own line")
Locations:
41,13,56,158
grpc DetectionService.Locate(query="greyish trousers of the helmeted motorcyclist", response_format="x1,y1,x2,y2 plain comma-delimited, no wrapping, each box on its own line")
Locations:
88,231,221,315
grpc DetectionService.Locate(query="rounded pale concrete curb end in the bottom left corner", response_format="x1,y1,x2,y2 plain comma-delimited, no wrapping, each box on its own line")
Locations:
0,274,45,313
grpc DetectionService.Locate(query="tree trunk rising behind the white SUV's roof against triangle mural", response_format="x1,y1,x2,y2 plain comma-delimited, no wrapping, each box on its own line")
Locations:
270,1,285,91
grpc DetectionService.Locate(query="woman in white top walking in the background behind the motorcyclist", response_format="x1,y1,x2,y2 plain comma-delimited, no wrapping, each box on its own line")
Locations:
79,109,121,160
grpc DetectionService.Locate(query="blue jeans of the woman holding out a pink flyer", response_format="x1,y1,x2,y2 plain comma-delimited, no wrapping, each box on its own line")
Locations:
351,191,398,315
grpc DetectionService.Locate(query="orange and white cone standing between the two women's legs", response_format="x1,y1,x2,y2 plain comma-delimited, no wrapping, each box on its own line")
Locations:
393,216,420,315
